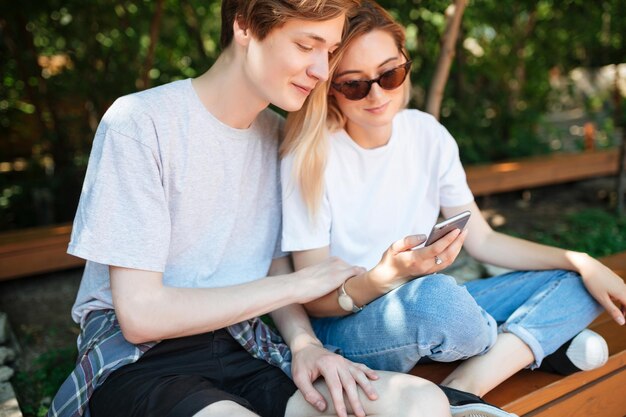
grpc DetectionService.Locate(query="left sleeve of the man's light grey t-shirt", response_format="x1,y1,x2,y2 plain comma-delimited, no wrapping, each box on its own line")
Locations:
68,108,170,272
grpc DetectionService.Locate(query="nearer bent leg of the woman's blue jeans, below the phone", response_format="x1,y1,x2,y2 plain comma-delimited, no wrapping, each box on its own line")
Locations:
312,274,497,372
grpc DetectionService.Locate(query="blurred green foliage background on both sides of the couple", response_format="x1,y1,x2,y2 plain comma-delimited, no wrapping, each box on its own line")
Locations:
0,0,626,230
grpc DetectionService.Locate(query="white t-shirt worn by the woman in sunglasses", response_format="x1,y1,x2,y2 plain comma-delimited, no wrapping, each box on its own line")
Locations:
281,110,474,268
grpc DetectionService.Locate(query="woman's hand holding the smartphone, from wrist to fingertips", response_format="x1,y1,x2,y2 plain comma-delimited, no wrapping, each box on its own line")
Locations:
368,229,467,290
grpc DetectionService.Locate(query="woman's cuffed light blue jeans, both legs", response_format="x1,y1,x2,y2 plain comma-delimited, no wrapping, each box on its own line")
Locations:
312,271,601,372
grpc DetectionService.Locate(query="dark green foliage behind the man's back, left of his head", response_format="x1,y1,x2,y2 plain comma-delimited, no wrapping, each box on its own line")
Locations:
0,0,220,230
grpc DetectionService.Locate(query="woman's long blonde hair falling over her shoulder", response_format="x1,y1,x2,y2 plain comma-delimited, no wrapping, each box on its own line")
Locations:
280,0,411,220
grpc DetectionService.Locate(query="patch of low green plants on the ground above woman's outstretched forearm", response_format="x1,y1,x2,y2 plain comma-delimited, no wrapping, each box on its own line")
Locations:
505,209,626,257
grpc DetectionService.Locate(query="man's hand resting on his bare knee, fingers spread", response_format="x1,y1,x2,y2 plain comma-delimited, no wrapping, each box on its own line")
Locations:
291,343,378,417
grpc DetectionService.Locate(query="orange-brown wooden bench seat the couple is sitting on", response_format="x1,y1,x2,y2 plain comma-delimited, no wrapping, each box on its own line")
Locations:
411,252,626,417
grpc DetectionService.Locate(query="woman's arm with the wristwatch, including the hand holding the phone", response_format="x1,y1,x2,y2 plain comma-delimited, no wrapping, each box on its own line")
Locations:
292,230,466,317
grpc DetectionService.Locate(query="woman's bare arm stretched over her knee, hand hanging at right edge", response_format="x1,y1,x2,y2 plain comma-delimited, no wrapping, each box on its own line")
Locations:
442,202,626,325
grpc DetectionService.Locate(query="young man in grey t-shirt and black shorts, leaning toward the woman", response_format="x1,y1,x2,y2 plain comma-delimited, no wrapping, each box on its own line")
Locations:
49,0,449,417
